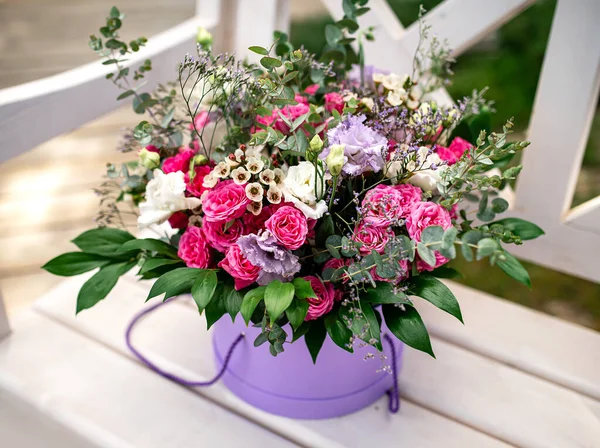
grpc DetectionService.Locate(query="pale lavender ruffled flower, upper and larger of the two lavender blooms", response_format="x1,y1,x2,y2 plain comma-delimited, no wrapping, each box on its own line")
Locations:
319,115,387,176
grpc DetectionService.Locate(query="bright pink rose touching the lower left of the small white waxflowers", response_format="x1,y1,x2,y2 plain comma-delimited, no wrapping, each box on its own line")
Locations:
202,180,250,222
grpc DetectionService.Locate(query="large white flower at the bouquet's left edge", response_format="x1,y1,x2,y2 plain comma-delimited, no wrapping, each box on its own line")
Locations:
138,170,201,229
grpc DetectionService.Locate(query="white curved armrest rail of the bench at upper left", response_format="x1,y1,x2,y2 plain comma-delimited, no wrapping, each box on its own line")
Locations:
0,15,215,162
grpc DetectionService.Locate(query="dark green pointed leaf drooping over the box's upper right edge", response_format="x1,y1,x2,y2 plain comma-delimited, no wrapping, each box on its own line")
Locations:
382,305,435,358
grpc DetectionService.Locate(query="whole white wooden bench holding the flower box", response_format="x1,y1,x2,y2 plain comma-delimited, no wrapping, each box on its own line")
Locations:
0,0,600,447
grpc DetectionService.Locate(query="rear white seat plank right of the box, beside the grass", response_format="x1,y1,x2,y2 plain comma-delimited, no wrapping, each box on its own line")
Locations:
415,282,600,400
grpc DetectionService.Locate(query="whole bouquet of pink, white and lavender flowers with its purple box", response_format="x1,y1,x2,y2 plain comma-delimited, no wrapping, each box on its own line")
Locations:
44,0,543,417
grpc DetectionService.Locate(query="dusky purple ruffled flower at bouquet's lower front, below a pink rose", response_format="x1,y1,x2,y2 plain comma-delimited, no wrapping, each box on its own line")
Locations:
237,230,300,285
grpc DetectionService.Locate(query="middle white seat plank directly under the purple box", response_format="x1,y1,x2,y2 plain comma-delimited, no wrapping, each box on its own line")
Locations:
35,277,504,448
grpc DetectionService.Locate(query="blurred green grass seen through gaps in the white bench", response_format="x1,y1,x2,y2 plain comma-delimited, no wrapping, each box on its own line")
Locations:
291,0,600,330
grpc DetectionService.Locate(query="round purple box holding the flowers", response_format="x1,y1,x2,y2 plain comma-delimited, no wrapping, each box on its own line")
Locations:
213,317,403,419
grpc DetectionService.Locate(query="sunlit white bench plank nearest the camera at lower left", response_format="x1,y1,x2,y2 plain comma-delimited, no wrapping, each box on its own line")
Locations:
0,315,292,448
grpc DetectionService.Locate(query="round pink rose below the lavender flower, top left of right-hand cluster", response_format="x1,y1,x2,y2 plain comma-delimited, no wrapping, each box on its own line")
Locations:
362,184,406,227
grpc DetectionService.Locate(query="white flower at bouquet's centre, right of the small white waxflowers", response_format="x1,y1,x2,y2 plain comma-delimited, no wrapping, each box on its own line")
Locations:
283,161,327,219
